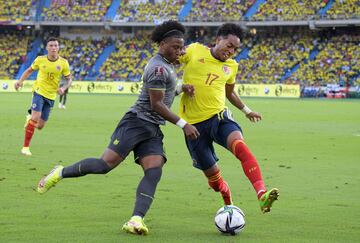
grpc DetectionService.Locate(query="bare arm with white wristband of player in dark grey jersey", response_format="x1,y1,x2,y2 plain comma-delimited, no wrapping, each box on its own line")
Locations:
149,89,200,139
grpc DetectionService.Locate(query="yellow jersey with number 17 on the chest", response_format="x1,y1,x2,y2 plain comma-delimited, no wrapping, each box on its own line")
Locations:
179,43,238,124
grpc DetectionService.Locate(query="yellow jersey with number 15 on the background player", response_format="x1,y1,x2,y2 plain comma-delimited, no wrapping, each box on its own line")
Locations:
31,56,70,100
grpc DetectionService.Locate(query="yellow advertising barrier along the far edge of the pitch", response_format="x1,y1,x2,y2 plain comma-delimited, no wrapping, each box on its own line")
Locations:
0,80,300,98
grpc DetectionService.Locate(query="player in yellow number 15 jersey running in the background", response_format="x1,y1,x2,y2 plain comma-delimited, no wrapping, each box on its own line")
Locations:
15,37,72,155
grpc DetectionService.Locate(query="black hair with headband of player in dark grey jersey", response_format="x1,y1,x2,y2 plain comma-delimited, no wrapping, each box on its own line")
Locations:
151,20,185,44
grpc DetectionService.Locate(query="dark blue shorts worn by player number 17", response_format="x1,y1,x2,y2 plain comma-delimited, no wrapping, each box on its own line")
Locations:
185,109,242,170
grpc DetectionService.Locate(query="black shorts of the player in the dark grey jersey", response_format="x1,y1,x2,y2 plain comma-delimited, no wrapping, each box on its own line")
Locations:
108,112,166,163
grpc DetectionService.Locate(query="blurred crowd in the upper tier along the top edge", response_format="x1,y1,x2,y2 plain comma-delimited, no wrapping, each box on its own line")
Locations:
0,0,360,23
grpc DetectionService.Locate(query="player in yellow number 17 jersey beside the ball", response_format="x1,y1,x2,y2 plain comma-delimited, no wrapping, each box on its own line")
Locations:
180,23,279,213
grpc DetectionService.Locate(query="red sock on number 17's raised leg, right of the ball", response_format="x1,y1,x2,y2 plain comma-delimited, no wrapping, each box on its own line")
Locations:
231,140,266,198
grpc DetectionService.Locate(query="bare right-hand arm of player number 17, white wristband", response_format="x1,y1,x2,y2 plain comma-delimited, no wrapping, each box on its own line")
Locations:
226,84,262,122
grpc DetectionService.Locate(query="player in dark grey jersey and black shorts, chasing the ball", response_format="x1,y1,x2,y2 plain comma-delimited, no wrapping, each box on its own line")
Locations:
37,21,199,234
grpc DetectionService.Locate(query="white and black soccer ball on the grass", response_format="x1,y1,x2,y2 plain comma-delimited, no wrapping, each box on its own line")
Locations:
215,205,245,235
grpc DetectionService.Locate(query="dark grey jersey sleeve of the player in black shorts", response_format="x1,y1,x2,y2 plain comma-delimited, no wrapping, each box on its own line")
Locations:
145,65,168,90
